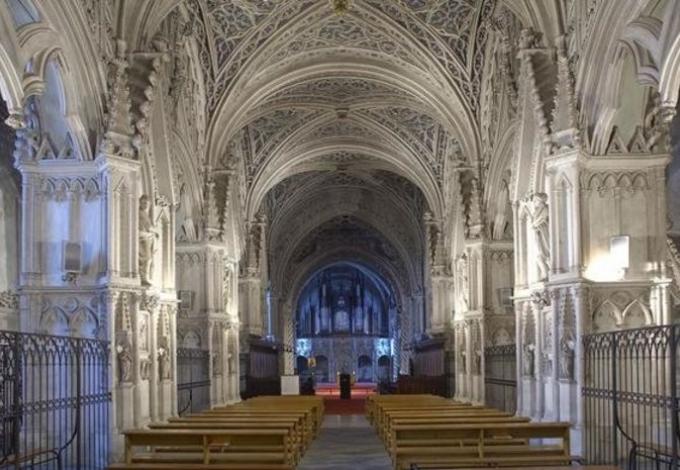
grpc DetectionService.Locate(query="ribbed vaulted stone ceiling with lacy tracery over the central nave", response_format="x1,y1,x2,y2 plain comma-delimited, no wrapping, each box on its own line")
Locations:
159,0,512,304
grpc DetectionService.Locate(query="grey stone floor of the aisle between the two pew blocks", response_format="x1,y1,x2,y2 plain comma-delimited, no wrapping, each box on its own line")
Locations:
298,415,392,470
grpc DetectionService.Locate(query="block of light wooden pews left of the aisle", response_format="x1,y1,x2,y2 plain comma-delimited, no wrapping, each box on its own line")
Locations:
110,396,324,470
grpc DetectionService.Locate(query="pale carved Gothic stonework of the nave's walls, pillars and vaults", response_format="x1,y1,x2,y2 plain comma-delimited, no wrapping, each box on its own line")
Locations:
0,0,680,462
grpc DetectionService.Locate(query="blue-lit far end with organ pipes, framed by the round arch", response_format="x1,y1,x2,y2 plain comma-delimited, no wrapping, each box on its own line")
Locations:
295,266,396,386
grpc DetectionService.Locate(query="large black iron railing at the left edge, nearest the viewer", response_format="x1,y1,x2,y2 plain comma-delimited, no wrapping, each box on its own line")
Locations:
0,331,111,470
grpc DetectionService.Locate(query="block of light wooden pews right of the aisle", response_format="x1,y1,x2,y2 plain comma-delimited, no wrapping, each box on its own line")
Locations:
366,395,574,470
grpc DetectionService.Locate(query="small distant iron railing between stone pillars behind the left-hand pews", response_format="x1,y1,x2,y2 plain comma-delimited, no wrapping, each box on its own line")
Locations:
177,348,210,415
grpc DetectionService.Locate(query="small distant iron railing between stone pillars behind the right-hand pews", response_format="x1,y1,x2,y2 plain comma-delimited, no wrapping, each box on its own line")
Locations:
484,344,517,413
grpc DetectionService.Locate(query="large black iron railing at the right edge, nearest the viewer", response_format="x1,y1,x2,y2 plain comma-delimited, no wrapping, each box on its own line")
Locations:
582,325,680,469
